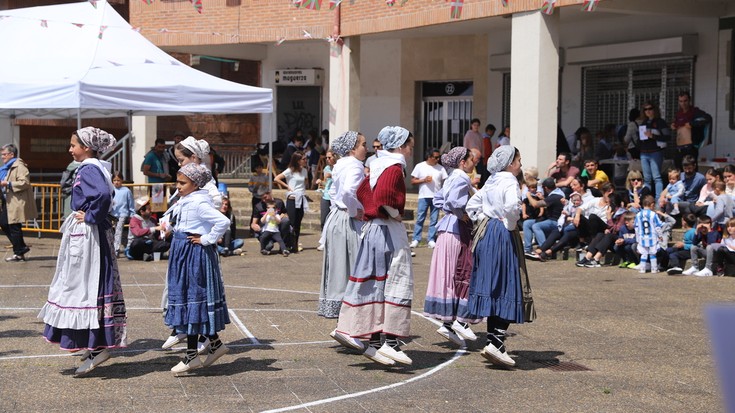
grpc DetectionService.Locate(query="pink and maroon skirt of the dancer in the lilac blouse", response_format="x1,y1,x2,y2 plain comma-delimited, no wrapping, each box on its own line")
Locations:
424,221,482,324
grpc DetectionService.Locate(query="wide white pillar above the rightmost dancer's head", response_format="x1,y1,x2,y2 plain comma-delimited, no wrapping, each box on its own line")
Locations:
510,11,559,177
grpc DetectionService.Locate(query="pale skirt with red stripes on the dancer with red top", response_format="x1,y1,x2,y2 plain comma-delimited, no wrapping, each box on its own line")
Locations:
337,219,413,338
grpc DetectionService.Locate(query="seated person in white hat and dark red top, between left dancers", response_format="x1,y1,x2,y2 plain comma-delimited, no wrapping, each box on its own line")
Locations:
125,196,171,261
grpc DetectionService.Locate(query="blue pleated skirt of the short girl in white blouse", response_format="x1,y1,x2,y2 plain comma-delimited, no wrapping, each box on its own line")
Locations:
164,232,230,336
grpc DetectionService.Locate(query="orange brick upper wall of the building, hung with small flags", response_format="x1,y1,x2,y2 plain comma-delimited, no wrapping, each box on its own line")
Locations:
130,0,584,46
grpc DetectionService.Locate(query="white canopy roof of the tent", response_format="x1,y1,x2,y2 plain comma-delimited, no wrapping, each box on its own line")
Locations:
0,0,273,119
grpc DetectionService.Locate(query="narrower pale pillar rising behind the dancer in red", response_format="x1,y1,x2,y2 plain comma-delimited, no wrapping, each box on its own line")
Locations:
329,37,360,136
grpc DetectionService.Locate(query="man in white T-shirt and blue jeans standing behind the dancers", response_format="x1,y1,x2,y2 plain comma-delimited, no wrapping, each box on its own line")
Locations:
411,149,448,248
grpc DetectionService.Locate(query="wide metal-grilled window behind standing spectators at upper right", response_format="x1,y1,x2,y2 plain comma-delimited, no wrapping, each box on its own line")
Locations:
582,57,694,133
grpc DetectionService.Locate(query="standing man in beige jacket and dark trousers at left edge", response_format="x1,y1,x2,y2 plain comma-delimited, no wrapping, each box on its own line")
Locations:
0,143,38,262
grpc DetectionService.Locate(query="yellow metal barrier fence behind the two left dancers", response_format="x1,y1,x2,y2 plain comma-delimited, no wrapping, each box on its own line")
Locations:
22,182,175,233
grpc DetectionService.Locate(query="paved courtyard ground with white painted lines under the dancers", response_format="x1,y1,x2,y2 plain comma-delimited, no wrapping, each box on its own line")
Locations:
0,233,735,413
